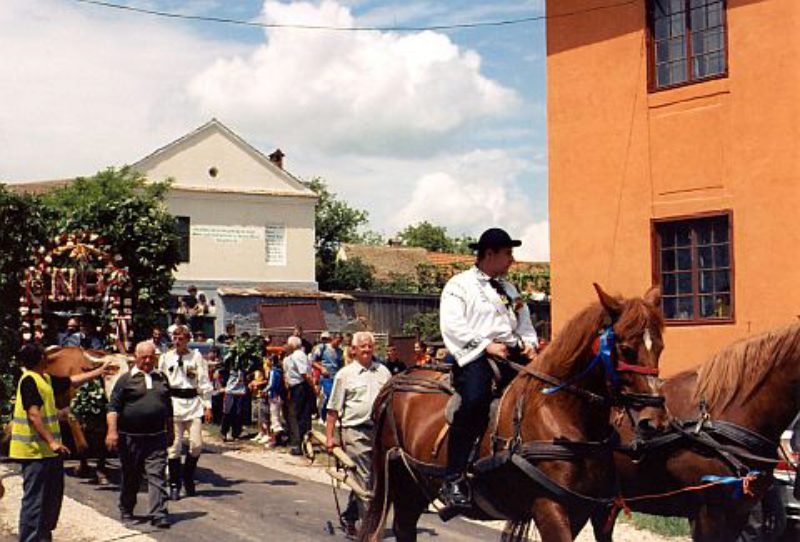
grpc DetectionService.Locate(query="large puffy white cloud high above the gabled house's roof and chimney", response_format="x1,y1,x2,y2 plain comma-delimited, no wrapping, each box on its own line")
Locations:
189,0,521,155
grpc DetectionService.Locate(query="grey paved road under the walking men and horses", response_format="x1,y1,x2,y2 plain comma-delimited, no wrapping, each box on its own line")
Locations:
66,452,499,542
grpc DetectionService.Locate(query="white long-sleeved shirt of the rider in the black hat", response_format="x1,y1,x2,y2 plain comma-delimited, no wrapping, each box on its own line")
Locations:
439,267,538,367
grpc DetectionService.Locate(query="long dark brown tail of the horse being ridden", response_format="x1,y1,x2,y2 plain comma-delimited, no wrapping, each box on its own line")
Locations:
357,386,393,542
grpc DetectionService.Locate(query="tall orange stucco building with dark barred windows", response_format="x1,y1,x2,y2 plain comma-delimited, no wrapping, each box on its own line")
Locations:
547,0,800,375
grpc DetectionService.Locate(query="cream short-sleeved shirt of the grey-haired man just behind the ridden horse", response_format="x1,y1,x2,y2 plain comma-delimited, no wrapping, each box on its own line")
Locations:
327,360,392,427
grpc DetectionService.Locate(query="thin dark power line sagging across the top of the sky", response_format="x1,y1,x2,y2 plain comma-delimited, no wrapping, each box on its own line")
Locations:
75,0,640,32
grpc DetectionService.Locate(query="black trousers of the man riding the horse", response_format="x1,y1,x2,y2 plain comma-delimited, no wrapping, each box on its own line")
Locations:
445,356,515,480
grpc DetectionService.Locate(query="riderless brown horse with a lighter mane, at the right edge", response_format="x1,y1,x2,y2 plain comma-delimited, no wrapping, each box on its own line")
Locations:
592,324,800,542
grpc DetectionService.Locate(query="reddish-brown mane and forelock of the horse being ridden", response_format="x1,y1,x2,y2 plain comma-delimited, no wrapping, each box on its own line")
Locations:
540,298,664,378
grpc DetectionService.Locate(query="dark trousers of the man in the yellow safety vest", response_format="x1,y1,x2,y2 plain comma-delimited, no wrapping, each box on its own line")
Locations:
19,457,64,542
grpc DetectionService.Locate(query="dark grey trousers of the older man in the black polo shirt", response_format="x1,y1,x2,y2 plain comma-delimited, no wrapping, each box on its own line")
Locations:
119,432,167,518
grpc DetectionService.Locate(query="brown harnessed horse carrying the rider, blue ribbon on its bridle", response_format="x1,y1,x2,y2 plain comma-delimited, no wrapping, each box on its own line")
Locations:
359,285,663,541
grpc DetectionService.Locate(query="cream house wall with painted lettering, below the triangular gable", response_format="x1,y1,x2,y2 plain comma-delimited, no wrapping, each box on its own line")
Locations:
167,190,316,288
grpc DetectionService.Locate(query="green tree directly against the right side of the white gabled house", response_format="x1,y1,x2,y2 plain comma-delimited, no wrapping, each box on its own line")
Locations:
308,177,368,290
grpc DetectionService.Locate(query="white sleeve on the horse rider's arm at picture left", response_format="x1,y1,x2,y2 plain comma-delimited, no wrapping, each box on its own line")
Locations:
439,279,492,365
